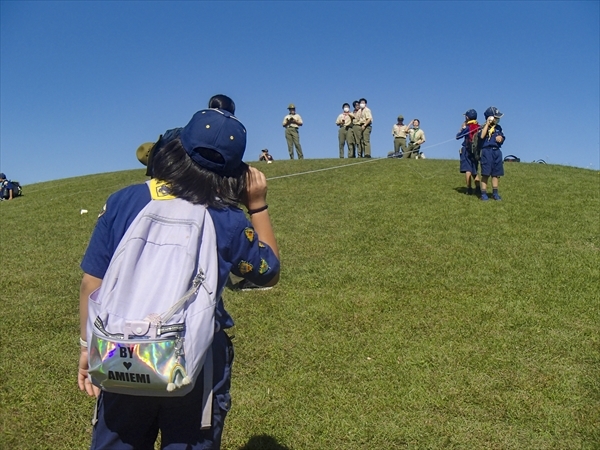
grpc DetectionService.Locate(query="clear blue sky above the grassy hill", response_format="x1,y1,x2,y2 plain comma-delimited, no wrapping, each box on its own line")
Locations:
0,1,600,184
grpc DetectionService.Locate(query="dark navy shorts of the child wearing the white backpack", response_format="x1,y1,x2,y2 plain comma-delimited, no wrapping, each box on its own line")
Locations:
90,331,233,450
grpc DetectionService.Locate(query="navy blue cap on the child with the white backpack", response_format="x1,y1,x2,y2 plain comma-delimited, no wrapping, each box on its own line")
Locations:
180,109,246,176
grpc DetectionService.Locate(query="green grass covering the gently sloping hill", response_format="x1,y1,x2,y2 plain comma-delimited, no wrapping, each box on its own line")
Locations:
0,159,600,450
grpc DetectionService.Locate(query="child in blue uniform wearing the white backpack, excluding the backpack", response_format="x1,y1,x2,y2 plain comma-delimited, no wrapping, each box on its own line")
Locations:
77,108,279,449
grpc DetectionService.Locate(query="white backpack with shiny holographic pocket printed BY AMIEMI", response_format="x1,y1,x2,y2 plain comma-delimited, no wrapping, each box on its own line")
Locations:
87,182,220,426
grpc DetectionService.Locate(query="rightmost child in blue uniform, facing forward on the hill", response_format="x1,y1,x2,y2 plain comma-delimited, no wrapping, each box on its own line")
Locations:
479,106,505,201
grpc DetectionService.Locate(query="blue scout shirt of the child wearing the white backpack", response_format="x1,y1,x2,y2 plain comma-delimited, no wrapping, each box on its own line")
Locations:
81,184,279,328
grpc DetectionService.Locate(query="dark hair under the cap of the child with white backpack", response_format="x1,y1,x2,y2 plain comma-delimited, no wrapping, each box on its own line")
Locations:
153,137,248,209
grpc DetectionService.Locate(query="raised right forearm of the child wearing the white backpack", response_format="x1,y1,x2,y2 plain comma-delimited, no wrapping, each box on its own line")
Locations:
244,167,279,286
